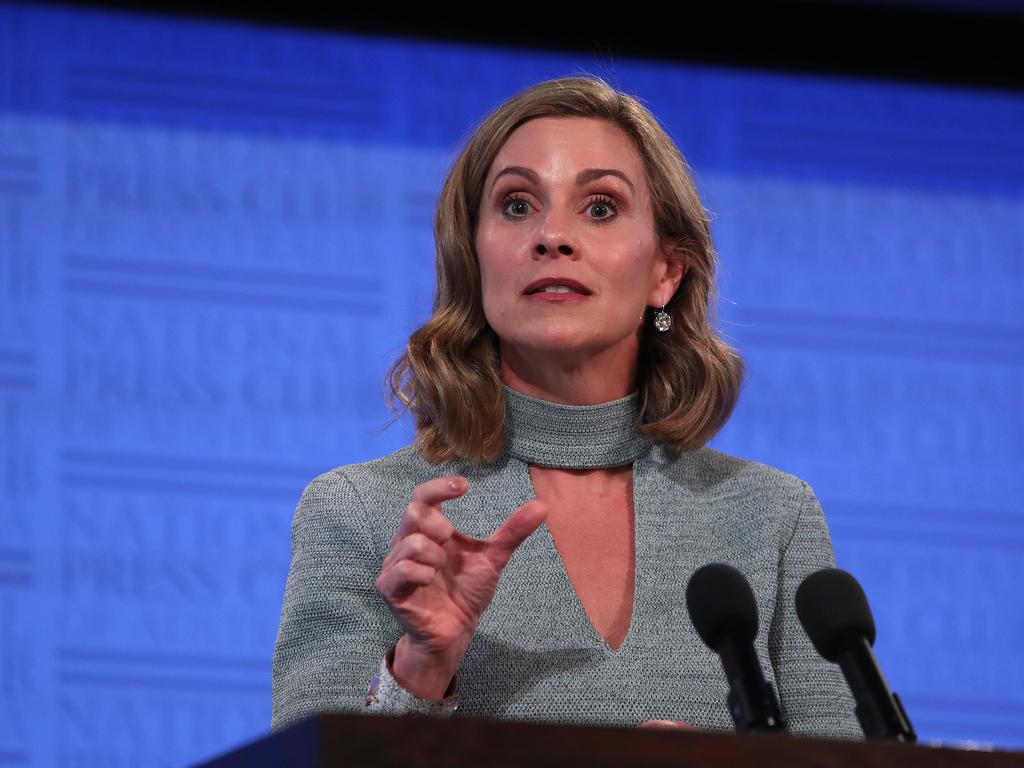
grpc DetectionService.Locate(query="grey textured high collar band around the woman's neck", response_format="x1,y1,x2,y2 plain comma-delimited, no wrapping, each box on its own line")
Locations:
505,386,652,469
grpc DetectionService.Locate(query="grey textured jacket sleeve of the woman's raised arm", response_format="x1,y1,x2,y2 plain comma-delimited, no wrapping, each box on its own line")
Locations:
270,470,398,730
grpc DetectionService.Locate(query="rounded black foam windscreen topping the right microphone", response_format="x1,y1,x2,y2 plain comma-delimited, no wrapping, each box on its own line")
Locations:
797,568,874,662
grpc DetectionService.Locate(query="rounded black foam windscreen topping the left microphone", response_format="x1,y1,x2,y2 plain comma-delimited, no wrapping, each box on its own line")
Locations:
686,563,758,651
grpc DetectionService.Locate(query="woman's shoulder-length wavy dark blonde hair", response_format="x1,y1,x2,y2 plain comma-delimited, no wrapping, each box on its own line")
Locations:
386,76,743,463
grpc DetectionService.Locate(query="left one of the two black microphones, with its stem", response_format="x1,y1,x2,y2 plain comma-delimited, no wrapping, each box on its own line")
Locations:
686,563,785,733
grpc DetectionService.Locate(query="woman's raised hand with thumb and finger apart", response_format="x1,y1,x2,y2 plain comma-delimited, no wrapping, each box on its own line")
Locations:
377,476,548,700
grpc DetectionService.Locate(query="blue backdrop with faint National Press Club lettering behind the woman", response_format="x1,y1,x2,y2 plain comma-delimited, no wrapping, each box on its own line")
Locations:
0,4,1024,767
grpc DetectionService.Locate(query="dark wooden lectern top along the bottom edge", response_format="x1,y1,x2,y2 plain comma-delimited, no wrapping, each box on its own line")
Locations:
201,714,1024,768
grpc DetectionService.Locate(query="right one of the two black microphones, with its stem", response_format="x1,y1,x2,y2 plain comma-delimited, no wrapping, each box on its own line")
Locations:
797,568,918,743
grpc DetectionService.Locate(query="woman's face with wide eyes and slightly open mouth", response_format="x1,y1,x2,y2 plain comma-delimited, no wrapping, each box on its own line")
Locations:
476,118,683,372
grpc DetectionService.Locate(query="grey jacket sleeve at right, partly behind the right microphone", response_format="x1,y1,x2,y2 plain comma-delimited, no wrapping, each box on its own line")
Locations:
768,481,863,739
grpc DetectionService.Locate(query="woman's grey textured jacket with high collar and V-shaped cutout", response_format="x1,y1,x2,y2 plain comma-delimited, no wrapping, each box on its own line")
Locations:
271,389,862,738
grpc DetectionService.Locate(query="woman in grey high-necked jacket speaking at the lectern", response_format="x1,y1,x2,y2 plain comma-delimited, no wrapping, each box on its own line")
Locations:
273,78,859,737
